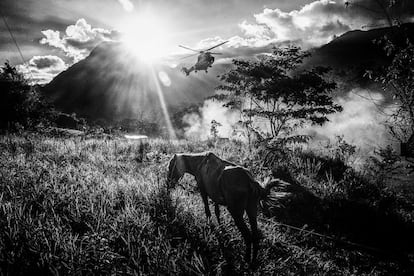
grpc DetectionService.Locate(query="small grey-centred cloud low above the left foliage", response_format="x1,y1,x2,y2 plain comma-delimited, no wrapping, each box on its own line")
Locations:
17,55,67,84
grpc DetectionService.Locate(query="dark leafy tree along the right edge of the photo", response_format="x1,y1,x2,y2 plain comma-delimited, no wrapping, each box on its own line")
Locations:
348,0,414,156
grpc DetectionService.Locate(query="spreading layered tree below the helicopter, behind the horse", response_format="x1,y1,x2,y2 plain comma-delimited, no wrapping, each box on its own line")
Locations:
213,46,342,147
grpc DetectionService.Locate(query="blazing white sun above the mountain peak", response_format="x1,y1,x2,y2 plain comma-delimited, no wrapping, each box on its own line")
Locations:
121,13,169,64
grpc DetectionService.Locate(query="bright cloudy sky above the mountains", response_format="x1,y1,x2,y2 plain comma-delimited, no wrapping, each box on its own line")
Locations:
0,0,414,83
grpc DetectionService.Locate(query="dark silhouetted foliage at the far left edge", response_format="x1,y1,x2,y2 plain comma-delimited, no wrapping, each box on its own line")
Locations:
0,62,53,130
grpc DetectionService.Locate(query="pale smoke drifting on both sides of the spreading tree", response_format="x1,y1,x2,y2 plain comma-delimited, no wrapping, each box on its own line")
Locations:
183,89,391,153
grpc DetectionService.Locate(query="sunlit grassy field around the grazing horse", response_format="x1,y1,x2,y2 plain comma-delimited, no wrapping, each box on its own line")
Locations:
0,134,414,275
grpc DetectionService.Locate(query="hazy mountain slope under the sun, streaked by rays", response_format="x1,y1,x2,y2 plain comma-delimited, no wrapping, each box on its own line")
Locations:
43,42,224,120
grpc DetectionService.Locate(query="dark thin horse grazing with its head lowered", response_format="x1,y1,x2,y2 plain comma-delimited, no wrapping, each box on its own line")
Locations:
167,152,280,263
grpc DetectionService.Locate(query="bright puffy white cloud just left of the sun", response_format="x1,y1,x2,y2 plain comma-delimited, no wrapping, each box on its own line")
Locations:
40,18,117,62
